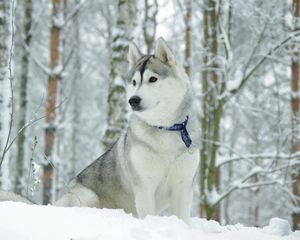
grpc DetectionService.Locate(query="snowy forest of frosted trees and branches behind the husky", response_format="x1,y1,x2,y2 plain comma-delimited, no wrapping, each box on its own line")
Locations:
0,0,300,234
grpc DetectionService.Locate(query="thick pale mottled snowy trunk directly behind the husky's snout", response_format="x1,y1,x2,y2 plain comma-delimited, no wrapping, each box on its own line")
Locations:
102,0,136,149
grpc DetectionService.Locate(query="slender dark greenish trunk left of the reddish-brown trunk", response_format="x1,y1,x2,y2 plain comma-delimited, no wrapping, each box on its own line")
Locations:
14,0,32,194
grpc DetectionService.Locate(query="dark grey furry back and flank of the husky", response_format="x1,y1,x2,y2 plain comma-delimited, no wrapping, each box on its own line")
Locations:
76,142,135,213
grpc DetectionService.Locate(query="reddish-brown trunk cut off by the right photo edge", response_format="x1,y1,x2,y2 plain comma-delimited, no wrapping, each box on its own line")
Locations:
291,0,300,230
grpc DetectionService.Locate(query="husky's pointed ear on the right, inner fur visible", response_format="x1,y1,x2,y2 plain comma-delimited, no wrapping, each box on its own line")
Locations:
154,37,176,65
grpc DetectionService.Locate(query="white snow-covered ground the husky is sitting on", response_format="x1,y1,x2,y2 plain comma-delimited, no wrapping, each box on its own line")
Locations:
0,202,300,240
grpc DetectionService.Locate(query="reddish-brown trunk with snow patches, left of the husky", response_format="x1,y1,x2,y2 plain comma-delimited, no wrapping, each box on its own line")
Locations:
43,0,63,204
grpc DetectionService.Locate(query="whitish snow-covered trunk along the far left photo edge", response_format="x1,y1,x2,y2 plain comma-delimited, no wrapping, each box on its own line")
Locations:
0,0,13,190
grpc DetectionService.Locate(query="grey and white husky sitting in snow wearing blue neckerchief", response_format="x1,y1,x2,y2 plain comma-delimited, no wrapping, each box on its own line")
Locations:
2,38,199,222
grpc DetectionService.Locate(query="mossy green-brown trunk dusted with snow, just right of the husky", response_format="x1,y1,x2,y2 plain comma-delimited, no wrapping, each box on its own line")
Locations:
200,0,221,220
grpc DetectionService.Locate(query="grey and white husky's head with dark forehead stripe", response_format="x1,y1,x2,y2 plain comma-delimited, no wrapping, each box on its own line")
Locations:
127,38,190,125
